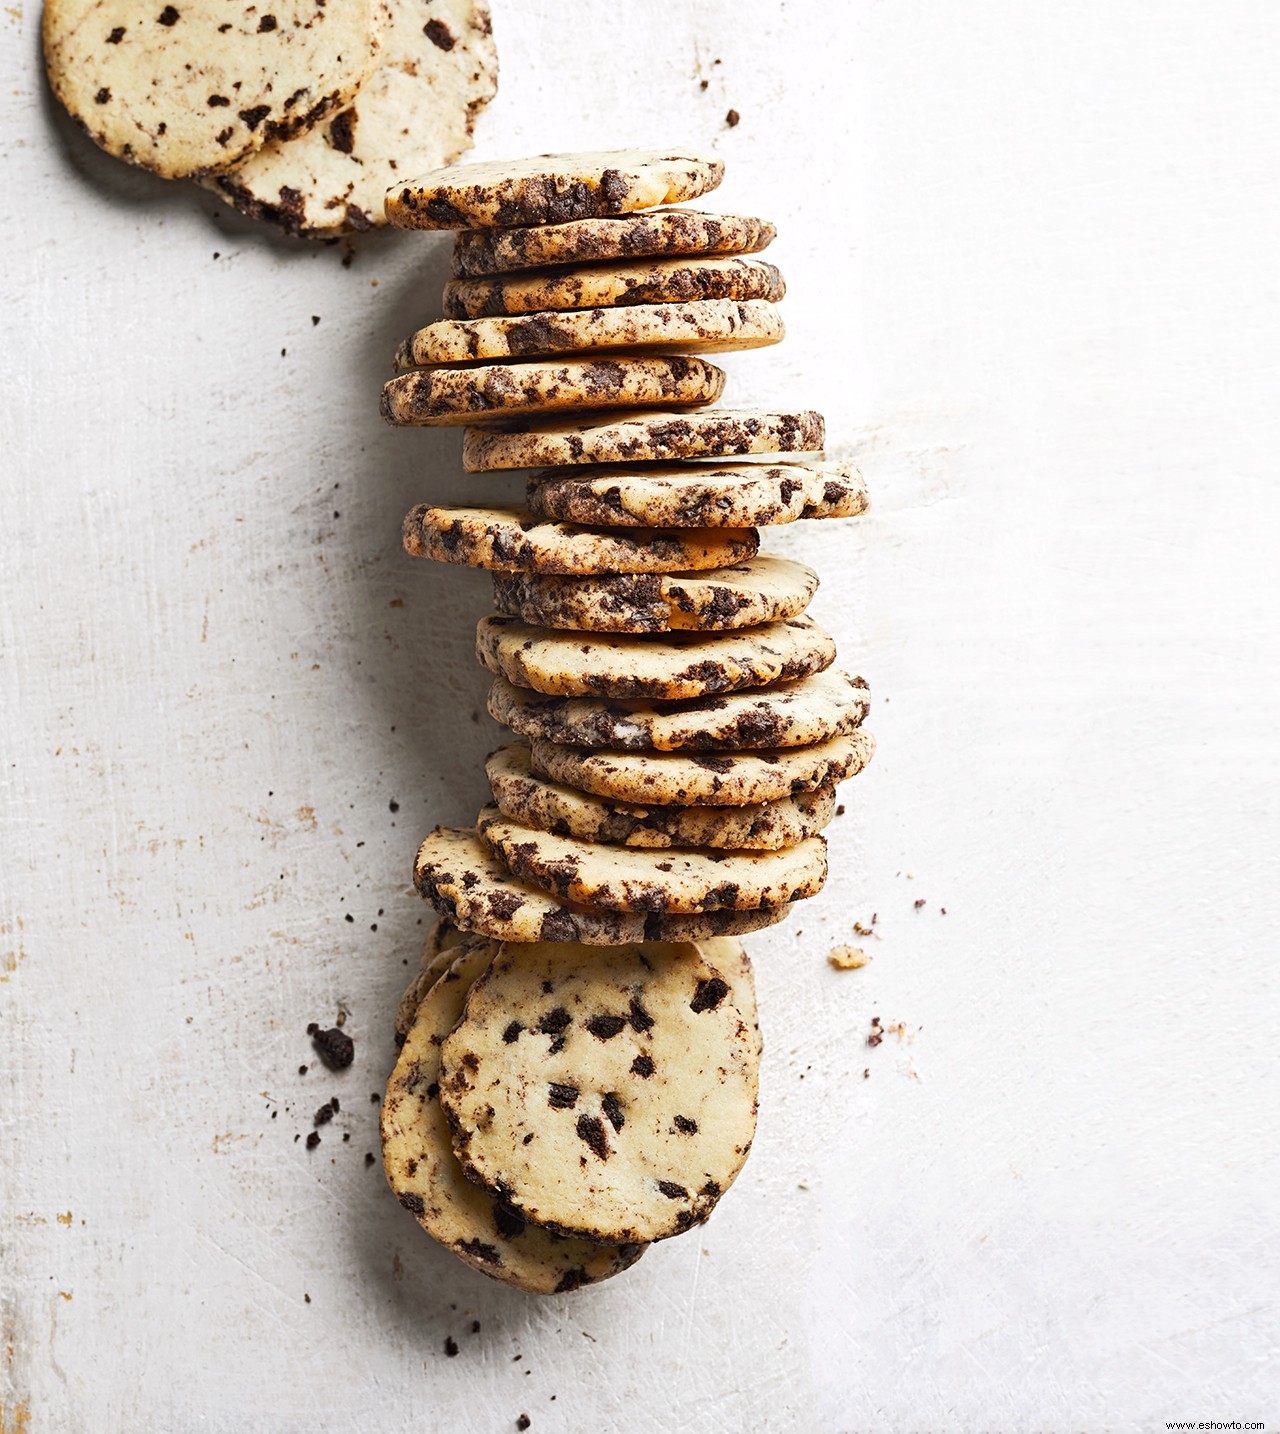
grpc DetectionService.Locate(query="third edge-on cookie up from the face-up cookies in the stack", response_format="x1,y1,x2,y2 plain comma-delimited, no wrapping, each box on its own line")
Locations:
484,743,836,852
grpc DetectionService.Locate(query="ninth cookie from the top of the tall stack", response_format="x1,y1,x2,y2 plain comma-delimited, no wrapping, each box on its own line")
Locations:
493,554,818,632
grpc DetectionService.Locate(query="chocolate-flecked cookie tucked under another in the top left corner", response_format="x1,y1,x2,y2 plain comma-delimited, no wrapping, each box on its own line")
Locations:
206,0,497,234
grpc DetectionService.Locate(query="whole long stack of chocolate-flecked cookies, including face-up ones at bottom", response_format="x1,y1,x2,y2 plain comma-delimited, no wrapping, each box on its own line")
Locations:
372,151,874,1292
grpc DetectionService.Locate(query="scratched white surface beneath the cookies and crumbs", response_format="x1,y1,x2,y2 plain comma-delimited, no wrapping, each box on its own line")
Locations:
0,0,1280,1434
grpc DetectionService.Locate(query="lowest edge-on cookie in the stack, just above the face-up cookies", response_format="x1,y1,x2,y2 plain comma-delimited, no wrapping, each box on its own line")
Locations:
413,826,791,946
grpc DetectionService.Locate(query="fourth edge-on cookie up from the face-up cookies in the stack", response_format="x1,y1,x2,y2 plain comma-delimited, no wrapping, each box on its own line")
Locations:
529,727,876,806
